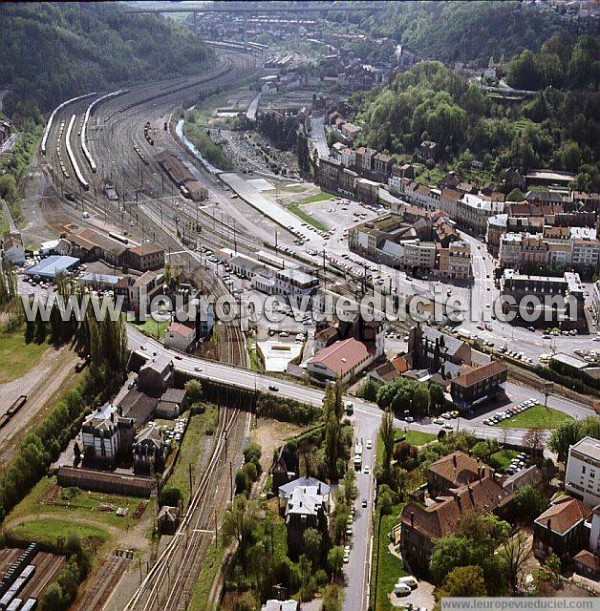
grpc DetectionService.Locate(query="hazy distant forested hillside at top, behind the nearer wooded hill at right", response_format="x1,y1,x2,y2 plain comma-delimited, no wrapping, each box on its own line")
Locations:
361,1,574,66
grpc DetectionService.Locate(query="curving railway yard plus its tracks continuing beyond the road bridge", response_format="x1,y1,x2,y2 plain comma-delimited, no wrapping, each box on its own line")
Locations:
0,44,271,611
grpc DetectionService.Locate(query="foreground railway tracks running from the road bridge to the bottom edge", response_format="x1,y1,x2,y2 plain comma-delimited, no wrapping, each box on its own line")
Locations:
123,408,245,611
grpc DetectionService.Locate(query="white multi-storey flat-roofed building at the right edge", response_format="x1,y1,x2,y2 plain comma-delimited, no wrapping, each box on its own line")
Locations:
565,437,600,507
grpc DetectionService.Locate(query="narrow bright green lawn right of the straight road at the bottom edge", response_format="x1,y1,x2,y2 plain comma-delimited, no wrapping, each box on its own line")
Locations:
371,505,408,611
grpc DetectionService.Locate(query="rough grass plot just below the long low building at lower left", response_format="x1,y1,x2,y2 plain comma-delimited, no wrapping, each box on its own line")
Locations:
7,477,152,529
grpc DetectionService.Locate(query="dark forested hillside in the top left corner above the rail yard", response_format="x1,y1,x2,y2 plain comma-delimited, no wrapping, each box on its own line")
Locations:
0,2,212,110
